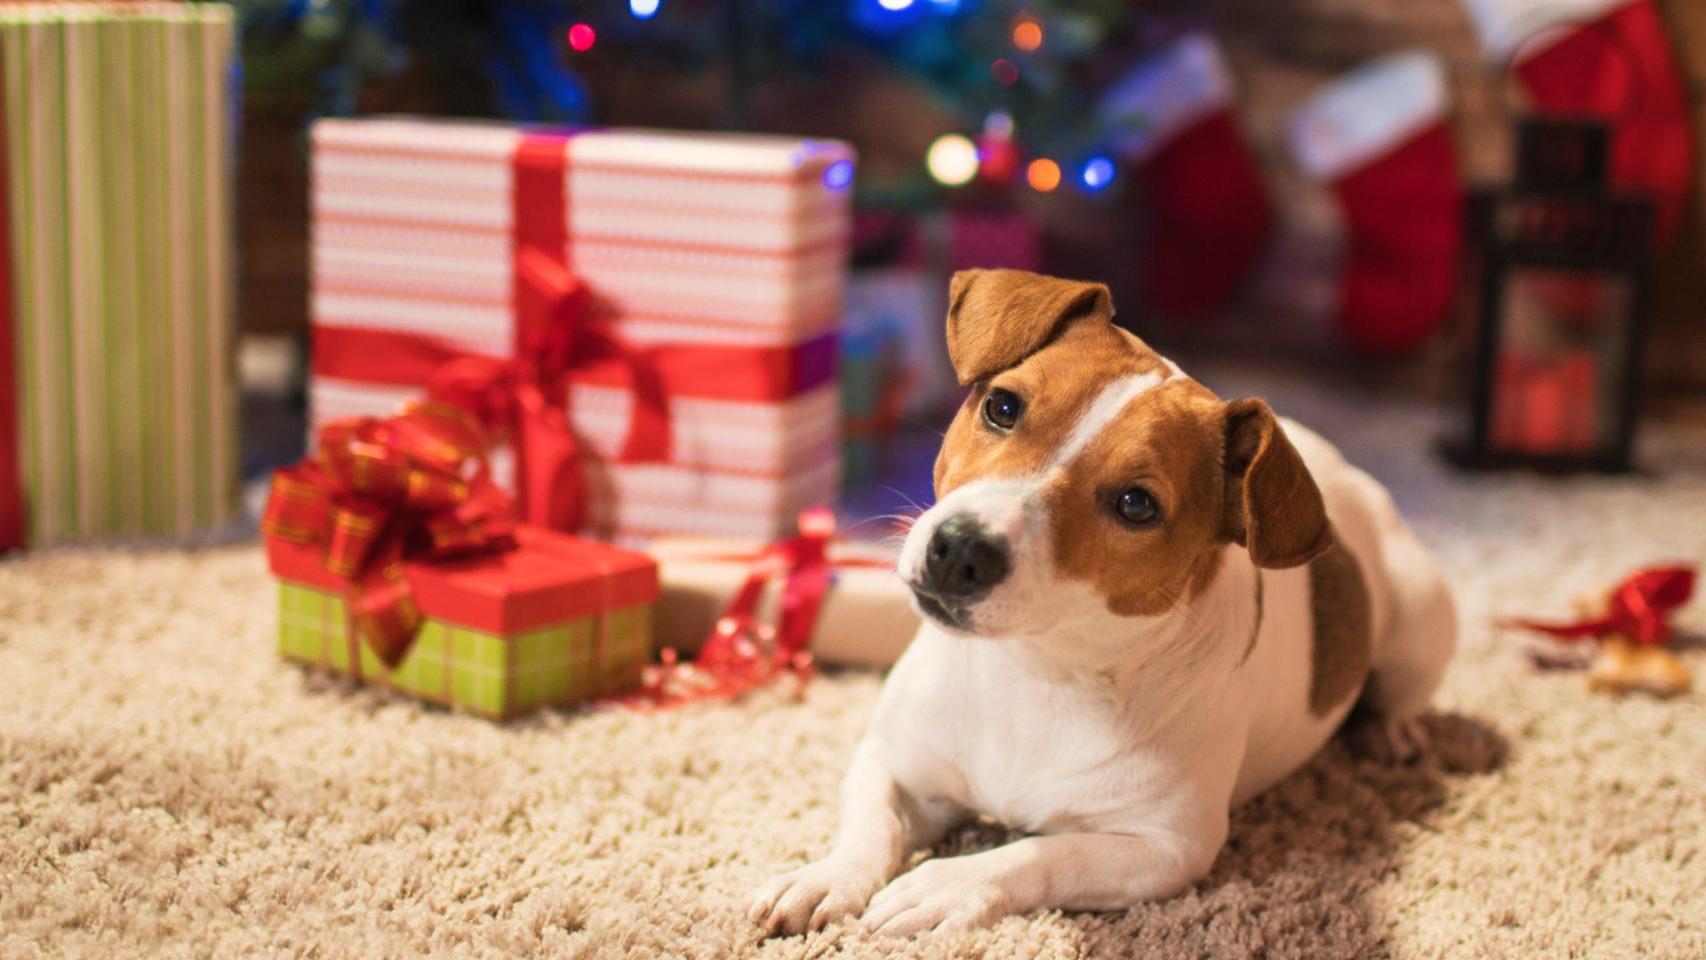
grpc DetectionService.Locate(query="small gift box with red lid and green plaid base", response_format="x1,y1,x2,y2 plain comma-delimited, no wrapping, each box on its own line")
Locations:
264,400,659,720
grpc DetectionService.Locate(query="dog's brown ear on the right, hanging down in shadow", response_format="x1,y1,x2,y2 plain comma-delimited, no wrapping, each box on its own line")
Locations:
1225,399,1332,568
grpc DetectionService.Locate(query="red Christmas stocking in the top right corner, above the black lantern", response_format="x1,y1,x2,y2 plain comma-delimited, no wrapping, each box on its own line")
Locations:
1464,0,1694,244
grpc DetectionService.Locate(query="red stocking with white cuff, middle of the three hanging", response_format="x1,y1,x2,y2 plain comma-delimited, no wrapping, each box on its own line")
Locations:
1291,53,1462,355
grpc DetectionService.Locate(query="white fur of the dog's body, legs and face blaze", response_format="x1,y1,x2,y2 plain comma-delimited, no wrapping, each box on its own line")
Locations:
749,363,1455,936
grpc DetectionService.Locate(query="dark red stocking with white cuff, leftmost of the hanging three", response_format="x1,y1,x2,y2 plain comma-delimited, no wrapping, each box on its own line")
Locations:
1100,34,1273,319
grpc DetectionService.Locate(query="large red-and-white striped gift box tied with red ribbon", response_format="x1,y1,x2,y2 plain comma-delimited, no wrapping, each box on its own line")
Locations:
310,118,853,539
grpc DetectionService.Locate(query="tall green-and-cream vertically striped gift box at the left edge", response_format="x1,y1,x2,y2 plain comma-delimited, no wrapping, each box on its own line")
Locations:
0,3,237,549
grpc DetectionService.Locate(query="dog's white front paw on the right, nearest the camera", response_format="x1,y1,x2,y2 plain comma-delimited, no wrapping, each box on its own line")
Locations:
862,856,1013,936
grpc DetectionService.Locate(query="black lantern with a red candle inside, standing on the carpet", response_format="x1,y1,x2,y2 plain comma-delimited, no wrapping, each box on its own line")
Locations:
1447,118,1653,472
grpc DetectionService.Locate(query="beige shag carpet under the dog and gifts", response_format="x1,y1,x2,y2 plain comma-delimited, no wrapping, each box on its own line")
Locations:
0,380,1706,958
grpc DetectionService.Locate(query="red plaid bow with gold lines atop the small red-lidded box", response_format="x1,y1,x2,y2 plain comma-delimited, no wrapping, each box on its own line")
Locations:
261,402,515,667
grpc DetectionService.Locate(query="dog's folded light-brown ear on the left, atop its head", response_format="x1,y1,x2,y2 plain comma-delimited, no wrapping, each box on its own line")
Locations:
949,269,1114,384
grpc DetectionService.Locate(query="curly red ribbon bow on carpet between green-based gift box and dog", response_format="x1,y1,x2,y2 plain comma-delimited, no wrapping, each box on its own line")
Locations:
621,506,887,709
